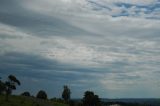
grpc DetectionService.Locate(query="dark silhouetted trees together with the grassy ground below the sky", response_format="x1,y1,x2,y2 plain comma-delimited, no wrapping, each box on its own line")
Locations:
0,75,160,106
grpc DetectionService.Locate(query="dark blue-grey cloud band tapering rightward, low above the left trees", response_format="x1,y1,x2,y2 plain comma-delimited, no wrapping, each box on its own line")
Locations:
0,52,102,80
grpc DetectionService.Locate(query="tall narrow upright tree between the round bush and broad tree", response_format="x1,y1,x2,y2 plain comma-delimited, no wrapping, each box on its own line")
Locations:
62,85,71,102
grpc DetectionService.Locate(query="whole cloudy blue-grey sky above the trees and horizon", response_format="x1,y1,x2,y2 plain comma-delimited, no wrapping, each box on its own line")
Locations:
0,0,160,98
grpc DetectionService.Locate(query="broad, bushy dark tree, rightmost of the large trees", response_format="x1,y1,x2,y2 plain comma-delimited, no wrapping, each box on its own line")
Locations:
82,91,100,106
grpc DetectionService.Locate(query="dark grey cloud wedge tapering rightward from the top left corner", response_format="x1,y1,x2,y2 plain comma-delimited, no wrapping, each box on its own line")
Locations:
0,0,90,37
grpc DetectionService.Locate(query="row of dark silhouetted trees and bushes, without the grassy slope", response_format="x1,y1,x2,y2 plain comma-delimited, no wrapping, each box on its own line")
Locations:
0,75,155,106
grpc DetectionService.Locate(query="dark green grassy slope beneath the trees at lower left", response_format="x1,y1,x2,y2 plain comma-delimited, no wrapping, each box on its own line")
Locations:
0,95,68,106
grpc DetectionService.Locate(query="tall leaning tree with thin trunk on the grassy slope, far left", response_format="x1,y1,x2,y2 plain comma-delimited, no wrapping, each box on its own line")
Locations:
5,75,21,101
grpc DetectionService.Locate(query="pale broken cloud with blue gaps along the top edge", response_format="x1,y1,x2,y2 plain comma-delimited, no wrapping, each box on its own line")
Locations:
20,0,159,18
